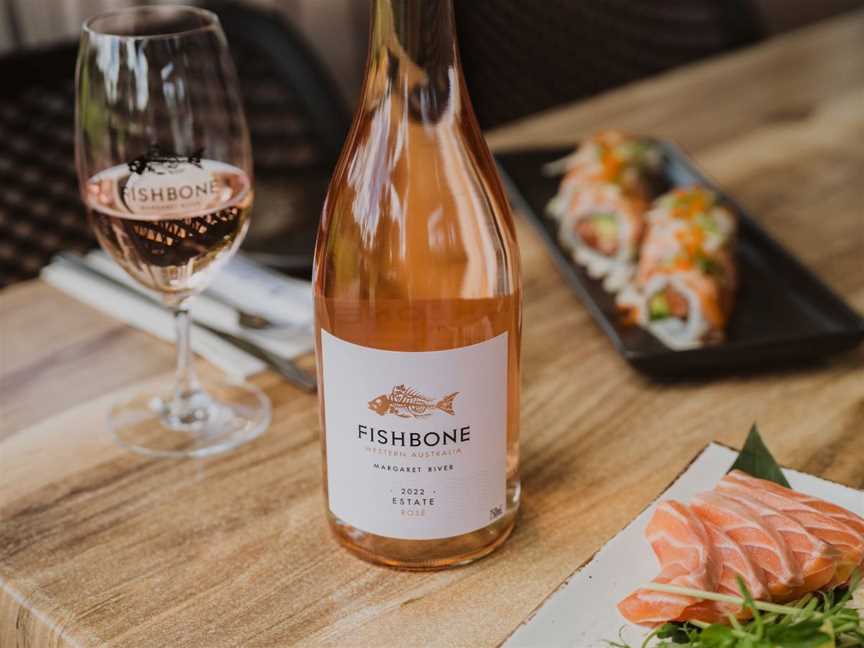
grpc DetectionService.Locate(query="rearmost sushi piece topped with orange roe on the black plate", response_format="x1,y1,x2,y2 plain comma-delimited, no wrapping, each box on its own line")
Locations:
545,130,661,218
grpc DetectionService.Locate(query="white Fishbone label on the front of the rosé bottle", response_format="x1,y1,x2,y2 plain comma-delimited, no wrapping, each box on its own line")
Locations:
321,330,507,540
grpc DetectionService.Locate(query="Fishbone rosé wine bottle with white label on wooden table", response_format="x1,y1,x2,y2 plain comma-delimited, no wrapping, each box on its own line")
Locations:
313,0,522,570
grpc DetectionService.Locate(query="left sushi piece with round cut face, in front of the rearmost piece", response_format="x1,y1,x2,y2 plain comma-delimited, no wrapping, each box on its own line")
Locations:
558,183,647,292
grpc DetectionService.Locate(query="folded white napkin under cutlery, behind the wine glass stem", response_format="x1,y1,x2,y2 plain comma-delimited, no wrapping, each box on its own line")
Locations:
42,250,313,378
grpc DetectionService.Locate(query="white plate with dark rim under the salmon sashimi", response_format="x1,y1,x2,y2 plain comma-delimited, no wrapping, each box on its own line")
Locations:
504,443,864,648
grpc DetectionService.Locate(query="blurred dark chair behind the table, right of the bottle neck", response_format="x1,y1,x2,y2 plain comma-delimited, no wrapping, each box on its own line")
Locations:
455,0,765,128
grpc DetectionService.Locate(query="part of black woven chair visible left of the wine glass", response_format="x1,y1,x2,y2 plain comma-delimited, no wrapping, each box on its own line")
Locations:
0,45,82,287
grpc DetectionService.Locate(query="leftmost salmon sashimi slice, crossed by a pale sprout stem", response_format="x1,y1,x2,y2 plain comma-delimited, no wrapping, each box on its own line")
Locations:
618,501,720,625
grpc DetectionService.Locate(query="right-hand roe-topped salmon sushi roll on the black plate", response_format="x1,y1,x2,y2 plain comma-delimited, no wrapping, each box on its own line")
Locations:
617,187,737,349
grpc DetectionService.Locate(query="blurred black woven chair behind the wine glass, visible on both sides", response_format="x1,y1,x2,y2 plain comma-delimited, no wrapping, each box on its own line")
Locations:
0,2,349,287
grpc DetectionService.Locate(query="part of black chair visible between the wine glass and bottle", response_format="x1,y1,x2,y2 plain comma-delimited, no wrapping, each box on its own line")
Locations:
211,1,350,274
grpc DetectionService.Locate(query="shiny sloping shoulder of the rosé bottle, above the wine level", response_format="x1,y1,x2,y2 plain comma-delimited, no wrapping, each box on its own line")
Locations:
315,106,518,297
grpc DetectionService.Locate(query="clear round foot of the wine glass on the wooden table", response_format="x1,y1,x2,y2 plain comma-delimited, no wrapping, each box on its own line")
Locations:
108,381,270,459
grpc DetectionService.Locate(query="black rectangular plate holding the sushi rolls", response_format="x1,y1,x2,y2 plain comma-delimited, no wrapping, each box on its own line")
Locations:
496,141,864,378
